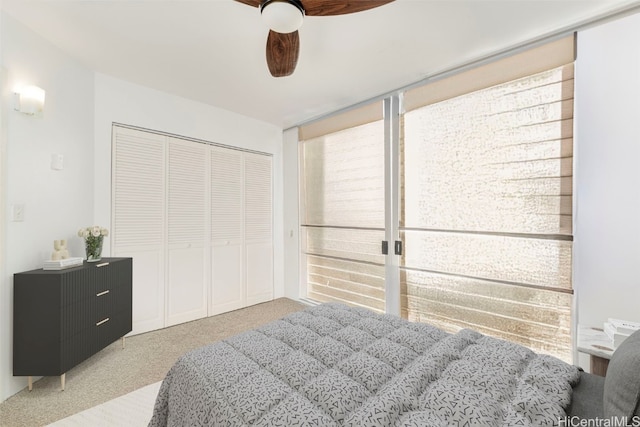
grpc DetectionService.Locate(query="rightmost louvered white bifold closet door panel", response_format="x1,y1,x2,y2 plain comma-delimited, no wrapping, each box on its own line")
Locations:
244,153,273,304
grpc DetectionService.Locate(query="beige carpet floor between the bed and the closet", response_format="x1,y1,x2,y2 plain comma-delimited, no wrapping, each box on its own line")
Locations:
0,298,306,427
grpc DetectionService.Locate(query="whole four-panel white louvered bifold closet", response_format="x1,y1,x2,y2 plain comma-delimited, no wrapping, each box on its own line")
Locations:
111,125,273,334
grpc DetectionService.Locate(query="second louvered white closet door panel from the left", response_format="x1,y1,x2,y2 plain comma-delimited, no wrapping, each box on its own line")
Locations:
167,138,209,326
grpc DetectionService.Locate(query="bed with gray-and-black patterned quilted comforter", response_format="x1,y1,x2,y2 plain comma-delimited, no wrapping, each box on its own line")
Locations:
149,303,640,427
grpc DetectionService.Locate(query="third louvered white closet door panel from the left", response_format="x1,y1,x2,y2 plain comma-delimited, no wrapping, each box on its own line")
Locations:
209,147,245,314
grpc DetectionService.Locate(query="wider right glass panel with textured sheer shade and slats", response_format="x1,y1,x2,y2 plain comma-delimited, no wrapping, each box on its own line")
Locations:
401,65,573,360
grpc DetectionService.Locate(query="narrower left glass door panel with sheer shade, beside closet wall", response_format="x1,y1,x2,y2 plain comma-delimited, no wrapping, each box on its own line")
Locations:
300,103,385,312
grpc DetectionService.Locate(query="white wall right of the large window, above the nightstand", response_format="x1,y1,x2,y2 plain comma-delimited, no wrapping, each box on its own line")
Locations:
573,14,640,367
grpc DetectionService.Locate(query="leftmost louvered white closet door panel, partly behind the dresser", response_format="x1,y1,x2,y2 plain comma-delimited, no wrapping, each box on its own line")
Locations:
111,126,166,334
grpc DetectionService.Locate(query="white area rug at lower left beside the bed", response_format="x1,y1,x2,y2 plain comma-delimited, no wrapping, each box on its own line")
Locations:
49,381,161,427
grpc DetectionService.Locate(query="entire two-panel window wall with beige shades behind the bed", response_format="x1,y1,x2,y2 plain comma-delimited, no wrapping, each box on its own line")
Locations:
300,37,574,361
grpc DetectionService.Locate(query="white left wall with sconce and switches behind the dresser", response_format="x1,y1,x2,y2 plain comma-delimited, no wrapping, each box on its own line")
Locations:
0,13,94,401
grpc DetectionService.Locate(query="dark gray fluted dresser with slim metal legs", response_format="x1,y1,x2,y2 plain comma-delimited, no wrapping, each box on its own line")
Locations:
13,258,132,390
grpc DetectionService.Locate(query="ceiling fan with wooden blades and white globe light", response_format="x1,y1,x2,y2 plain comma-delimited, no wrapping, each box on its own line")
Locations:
236,0,394,77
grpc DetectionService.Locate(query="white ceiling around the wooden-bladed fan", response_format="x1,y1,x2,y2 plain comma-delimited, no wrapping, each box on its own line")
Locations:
2,0,640,128
